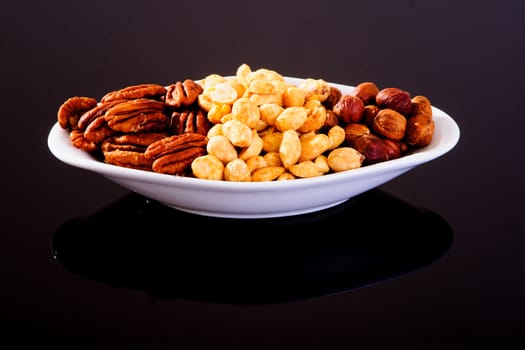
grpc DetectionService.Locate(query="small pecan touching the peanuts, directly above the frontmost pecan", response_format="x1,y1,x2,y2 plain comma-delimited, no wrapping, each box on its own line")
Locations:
169,108,212,135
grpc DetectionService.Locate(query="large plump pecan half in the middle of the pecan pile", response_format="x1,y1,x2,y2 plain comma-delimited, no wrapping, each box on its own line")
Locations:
104,98,169,133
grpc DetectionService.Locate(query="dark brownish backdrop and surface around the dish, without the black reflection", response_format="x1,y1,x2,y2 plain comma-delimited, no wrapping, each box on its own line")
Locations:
0,0,525,349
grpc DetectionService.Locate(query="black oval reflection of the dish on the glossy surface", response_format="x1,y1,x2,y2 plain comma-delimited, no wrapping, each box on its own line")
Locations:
52,189,453,304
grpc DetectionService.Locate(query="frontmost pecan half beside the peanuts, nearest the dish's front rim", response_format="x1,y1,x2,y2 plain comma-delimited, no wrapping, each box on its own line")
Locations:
144,133,208,175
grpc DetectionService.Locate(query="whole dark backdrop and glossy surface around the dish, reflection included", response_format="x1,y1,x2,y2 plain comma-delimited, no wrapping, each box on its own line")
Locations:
0,0,525,349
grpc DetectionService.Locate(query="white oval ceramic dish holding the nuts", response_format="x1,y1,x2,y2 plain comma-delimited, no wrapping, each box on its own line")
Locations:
48,77,460,218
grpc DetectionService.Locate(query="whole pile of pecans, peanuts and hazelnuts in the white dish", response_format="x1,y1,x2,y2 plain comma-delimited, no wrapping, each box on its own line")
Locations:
57,64,435,182
